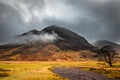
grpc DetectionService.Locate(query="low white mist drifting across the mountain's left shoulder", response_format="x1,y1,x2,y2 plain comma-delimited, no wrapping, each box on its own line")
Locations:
8,32,62,45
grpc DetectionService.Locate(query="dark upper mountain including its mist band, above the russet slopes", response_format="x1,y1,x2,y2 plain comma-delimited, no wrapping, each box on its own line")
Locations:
17,25,93,51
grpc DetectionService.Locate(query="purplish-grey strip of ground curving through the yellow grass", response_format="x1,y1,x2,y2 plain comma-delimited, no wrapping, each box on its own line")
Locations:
53,67,111,80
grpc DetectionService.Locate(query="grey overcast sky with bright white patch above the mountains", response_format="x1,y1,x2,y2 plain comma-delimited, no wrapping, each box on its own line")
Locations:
0,0,120,43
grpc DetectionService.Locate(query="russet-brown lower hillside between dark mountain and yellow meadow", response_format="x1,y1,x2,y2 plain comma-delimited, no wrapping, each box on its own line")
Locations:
0,44,95,61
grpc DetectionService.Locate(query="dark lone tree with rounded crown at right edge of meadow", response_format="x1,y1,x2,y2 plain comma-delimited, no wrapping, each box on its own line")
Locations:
98,45,116,67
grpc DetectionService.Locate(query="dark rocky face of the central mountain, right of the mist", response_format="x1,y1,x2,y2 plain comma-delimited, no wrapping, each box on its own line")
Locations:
42,26,92,50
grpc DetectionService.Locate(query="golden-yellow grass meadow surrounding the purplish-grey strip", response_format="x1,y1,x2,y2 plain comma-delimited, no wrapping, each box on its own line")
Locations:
0,61,120,80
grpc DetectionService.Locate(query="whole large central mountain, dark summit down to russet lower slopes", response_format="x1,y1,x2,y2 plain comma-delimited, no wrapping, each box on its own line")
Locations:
0,26,96,61
